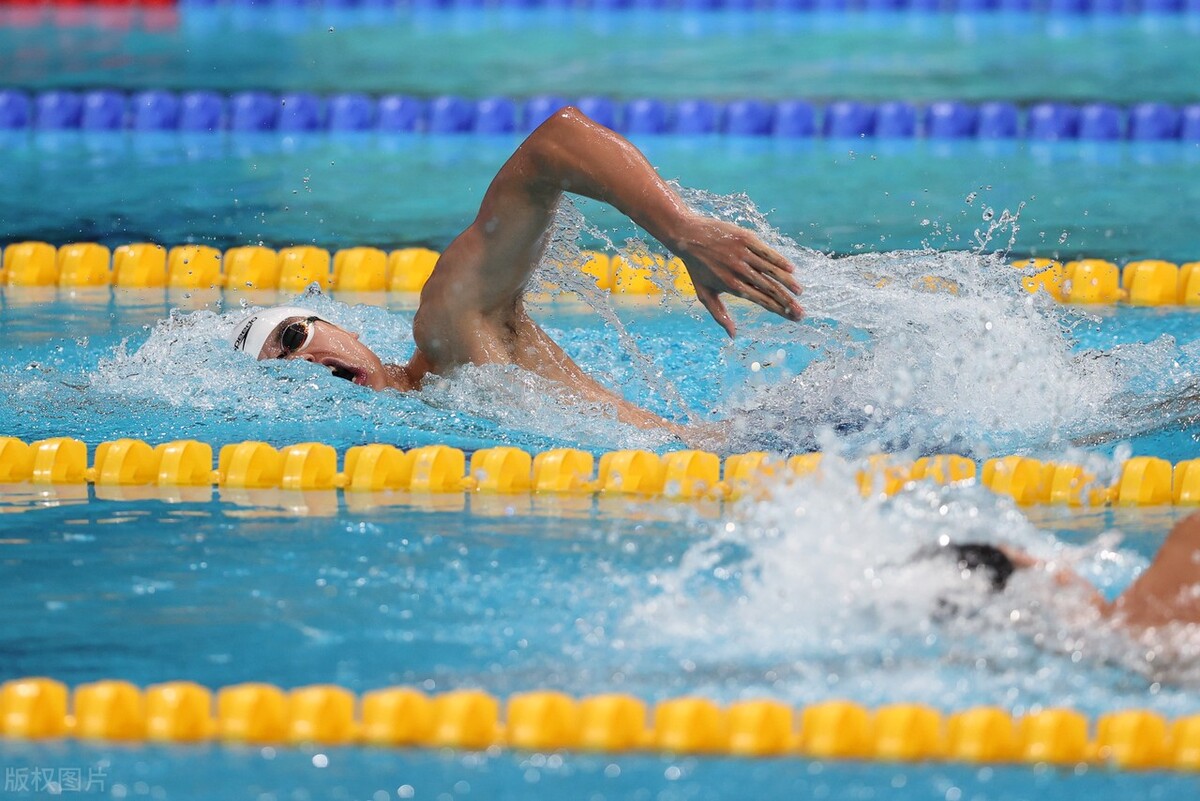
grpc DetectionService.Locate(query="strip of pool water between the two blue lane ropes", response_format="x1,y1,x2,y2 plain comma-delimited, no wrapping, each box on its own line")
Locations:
7,5,1200,103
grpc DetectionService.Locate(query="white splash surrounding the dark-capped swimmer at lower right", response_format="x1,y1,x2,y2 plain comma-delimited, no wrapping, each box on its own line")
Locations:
619,450,1200,713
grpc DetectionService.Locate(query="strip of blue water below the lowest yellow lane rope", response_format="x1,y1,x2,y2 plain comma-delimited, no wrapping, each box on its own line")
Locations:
12,743,1196,801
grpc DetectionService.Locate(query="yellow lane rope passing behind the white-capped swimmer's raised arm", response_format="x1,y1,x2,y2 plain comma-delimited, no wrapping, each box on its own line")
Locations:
0,241,1200,306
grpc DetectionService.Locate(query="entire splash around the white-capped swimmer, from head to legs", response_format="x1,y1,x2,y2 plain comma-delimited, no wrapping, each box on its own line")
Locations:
39,181,1200,456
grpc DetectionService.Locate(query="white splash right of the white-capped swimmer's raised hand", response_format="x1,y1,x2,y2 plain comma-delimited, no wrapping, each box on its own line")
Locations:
662,183,1200,454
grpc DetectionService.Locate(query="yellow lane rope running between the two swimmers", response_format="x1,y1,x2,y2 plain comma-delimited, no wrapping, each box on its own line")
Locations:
0,436,1200,506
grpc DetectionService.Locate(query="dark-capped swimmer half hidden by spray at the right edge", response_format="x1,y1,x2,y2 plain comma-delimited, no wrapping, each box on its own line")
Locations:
918,512,1200,633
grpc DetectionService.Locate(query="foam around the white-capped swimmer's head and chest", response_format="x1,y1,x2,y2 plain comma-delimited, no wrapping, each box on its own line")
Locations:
86,287,674,450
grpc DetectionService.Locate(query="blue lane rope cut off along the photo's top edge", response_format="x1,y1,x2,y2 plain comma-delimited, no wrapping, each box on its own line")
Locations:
180,0,1200,14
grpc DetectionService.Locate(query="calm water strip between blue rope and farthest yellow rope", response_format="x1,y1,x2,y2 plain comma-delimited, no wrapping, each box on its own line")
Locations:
7,132,1200,263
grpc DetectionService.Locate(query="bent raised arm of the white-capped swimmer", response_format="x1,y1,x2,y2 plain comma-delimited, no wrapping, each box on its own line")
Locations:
422,108,803,337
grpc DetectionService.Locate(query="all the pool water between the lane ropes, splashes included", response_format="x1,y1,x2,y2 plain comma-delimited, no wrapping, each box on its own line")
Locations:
0,1,1200,801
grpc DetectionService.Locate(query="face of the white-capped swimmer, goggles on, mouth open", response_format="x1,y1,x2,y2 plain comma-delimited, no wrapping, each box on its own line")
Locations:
258,317,388,390
